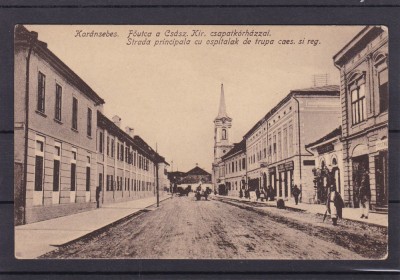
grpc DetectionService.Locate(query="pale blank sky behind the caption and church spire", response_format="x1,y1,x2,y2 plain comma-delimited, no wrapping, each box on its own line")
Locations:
26,25,363,172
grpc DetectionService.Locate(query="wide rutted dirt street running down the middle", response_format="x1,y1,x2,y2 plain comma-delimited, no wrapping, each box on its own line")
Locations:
42,196,387,260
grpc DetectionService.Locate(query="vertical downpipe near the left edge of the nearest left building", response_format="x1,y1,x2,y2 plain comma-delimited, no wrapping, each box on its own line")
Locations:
22,33,36,224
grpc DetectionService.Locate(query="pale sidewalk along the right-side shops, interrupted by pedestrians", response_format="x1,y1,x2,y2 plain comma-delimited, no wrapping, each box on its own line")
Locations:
216,196,388,227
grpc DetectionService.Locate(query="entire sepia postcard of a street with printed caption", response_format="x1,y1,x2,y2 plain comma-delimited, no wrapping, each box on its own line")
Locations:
14,24,390,260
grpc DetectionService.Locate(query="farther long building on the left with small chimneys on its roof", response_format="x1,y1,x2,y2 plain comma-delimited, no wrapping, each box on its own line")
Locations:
97,112,165,203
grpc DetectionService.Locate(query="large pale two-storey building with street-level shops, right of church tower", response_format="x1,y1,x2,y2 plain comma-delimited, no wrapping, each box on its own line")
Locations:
244,86,340,203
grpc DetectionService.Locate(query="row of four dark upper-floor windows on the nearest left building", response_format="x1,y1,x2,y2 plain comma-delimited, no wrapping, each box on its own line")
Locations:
36,72,92,137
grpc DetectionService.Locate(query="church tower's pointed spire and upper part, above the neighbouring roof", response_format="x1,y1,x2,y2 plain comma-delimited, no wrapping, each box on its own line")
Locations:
214,84,233,164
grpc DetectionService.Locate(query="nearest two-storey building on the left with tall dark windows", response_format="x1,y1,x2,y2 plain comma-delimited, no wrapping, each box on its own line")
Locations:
14,26,104,225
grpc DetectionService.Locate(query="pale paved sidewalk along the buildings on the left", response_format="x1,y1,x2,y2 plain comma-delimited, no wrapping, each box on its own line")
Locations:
14,195,171,259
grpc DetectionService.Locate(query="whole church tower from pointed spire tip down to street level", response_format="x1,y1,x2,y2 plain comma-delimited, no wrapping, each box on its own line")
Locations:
212,85,233,191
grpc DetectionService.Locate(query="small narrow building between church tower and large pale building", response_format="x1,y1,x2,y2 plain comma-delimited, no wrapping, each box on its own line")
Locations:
220,139,246,196
